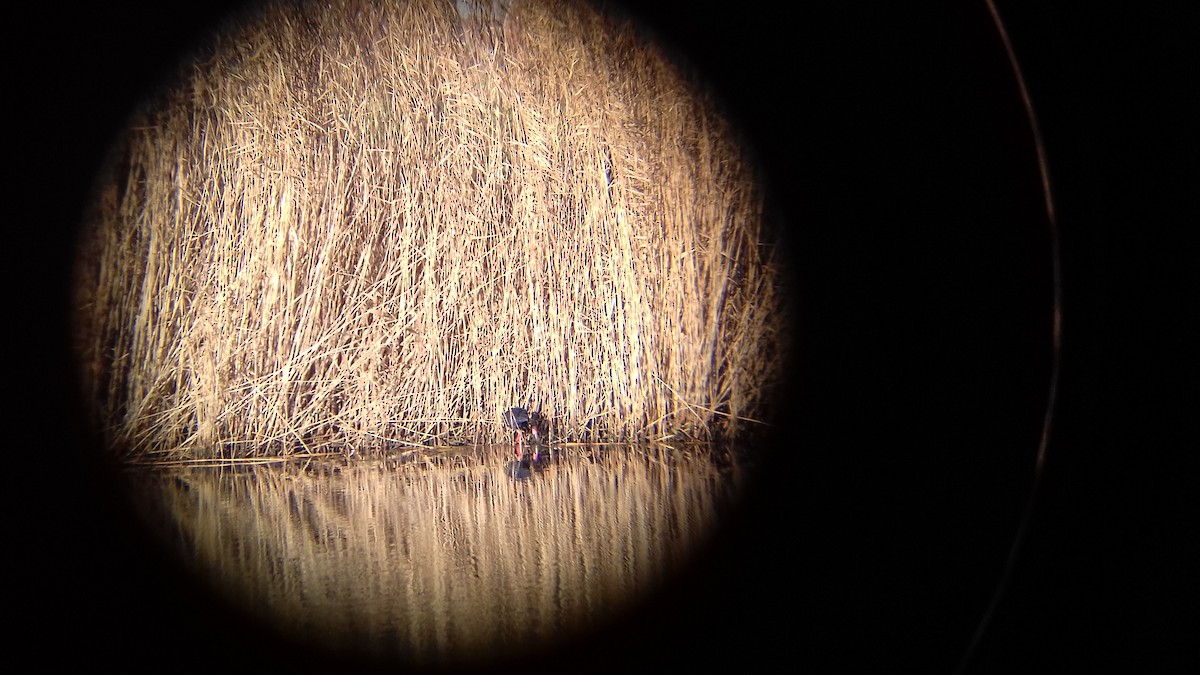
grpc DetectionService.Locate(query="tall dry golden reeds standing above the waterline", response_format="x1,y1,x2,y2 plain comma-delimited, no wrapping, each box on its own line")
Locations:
76,0,786,458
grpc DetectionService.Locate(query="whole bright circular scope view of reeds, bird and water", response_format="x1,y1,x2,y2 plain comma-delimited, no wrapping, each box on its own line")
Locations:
73,0,788,665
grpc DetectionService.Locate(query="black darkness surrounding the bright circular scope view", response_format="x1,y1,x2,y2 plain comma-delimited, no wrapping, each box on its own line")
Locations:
16,1,1200,673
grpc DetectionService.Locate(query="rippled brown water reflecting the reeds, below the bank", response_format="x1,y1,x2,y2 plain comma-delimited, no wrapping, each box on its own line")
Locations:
126,446,738,665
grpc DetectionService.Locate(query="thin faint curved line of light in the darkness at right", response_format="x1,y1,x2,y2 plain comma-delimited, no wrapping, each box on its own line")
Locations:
956,0,1062,674
